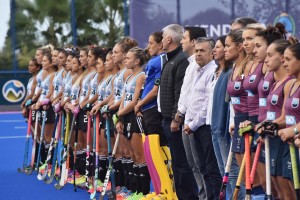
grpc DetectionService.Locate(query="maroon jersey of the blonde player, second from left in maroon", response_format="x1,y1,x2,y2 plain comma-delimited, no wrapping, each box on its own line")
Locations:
243,63,264,116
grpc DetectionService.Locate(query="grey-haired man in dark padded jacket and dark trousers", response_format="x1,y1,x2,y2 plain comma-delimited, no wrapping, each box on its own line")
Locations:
158,24,198,200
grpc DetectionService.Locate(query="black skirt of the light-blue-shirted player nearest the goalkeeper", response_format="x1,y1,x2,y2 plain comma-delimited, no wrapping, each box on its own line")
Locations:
123,111,141,140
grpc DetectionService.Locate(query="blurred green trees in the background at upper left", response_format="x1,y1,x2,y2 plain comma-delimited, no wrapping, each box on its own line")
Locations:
0,0,124,70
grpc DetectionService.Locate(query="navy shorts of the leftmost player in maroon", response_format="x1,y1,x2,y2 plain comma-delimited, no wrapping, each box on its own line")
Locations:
231,113,248,154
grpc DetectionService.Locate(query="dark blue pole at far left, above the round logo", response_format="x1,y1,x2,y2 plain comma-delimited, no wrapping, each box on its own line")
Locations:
10,0,18,77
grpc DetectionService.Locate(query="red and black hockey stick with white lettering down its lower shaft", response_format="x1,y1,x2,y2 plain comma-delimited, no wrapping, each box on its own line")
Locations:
85,115,91,190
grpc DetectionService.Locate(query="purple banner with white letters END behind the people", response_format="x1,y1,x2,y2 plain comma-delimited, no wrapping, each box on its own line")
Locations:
129,0,300,47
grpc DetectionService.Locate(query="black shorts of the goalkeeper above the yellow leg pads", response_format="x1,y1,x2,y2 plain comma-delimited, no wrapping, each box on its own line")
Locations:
142,106,168,146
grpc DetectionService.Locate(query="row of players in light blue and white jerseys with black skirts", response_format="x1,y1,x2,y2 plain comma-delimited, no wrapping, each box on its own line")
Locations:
21,35,166,197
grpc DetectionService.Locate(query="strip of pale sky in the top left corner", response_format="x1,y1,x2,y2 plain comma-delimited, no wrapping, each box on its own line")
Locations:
0,0,10,50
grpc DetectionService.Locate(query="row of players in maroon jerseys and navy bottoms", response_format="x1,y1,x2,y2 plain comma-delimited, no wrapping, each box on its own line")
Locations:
223,24,300,199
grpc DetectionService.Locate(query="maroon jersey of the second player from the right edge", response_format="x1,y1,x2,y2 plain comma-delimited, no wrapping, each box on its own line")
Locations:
267,76,293,121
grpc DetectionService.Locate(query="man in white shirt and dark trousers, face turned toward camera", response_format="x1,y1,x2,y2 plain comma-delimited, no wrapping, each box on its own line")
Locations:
183,37,222,200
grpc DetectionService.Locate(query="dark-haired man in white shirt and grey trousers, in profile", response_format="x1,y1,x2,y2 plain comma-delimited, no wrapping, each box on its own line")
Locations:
175,26,206,200
